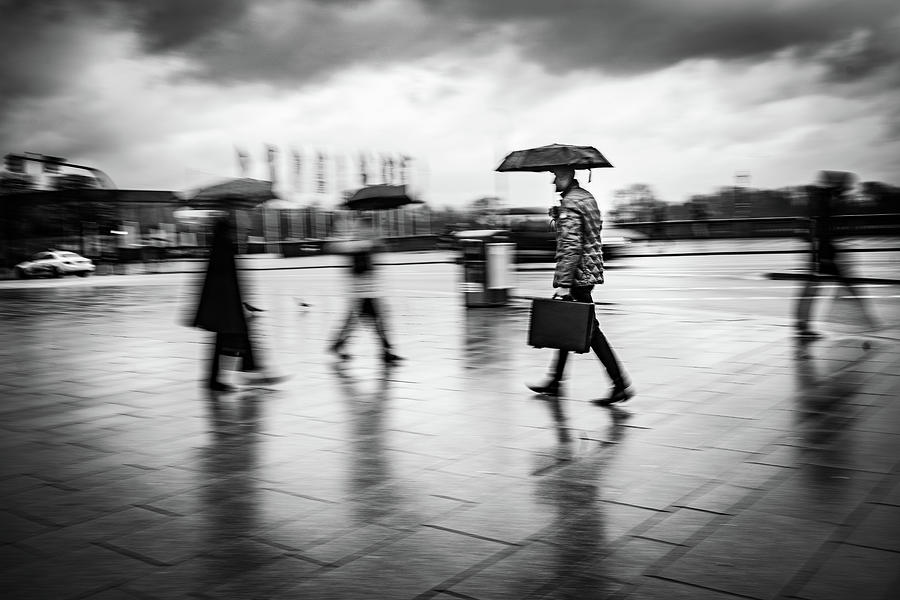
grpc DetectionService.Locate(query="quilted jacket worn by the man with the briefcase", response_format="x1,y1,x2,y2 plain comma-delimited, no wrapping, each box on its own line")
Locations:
553,181,603,287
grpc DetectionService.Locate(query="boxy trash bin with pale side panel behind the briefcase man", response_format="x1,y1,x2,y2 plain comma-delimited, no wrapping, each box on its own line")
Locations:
456,229,516,308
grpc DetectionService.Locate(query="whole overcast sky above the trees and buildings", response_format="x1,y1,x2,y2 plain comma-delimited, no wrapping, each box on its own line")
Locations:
0,0,900,211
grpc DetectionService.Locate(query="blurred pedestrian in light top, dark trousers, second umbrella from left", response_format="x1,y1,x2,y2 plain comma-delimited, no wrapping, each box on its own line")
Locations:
329,217,402,364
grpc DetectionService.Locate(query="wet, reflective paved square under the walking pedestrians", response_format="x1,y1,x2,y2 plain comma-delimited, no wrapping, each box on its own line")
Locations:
0,254,900,600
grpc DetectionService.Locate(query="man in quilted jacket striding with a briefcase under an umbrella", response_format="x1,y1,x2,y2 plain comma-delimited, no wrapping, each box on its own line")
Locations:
528,167,634,406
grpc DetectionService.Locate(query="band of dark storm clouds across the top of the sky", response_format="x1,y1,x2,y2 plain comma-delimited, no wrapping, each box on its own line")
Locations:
0,0,900,118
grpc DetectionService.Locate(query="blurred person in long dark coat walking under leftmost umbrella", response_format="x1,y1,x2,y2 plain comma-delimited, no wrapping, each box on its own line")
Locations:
193,218,257,391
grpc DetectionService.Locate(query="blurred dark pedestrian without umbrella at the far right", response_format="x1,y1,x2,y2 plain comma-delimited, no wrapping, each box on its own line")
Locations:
795,171,875,340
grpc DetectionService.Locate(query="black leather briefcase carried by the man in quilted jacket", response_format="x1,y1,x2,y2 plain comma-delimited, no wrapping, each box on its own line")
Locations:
528,298,594,354
